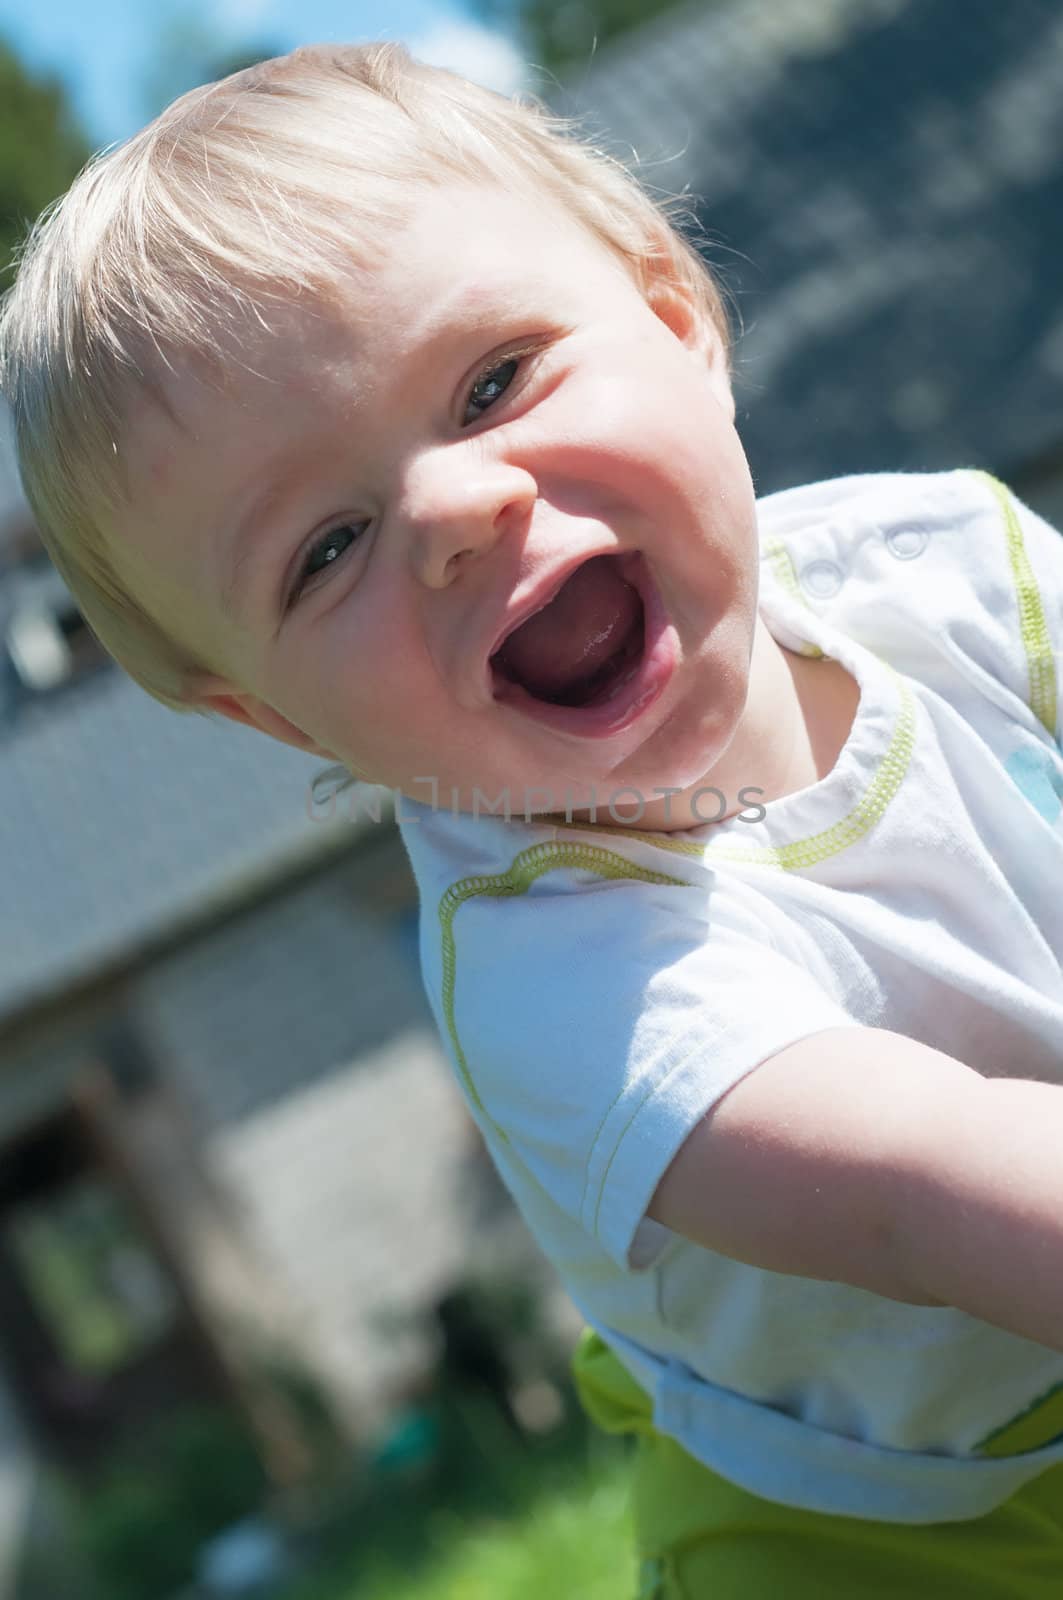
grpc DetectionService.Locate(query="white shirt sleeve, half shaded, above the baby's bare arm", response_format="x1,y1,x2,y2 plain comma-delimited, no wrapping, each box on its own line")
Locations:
445,872,855,1269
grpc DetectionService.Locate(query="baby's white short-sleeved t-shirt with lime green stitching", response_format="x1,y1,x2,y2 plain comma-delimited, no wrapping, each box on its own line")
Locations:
400,472,1063,1522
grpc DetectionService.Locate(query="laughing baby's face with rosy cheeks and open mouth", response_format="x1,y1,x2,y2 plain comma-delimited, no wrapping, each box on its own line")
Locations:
120,184,757,811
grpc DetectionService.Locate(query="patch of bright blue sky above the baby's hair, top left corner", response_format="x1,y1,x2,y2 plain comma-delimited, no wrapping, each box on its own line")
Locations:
0,0,522,144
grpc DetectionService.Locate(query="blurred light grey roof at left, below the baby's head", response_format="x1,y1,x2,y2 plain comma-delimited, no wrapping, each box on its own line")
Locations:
0,550,368,1021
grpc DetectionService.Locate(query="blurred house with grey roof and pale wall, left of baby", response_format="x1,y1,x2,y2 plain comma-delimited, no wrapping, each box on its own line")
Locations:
0,406,541,1595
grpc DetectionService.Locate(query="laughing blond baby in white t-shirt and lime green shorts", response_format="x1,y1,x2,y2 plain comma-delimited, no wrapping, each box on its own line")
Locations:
0,45,1063,1600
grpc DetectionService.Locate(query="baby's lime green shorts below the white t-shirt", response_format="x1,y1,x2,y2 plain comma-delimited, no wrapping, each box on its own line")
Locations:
573,1330,1063,1600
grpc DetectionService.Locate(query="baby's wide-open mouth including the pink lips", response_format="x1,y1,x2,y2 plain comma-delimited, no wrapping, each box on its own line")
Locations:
491,554,671,736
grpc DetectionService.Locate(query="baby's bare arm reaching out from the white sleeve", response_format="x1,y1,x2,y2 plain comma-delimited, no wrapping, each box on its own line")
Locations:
648,1027,1063,1350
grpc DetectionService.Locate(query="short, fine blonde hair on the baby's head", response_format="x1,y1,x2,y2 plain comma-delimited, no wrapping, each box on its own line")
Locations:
0,45,728,710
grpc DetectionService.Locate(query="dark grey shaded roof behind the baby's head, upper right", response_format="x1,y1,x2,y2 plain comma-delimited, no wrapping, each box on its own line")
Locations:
562,0,1063,493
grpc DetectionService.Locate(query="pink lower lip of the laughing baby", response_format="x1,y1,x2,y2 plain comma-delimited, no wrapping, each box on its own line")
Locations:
495,555,677,739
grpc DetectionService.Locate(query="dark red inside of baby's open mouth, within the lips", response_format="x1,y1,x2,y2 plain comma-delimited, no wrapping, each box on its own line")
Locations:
498,555,642,699
